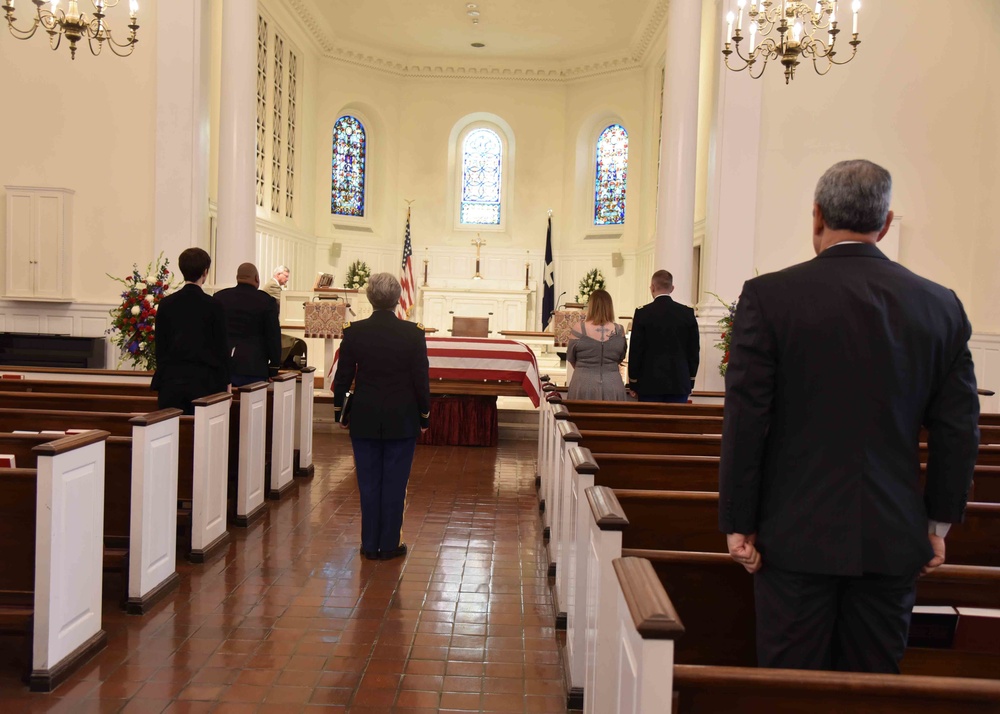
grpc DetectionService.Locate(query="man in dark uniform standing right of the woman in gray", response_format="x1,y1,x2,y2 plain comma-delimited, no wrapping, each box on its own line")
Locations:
628,270,701,403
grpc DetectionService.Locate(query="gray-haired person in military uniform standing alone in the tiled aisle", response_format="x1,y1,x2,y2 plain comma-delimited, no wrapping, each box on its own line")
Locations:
333,273,431,560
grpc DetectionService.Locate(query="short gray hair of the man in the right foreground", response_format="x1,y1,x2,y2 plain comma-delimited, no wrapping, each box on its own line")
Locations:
815,159,892,233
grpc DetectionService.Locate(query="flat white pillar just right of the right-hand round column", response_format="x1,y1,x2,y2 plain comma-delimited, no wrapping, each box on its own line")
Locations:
698,0,764,312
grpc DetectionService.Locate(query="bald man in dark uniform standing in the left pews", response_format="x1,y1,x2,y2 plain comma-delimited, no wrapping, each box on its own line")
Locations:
215,263,281,387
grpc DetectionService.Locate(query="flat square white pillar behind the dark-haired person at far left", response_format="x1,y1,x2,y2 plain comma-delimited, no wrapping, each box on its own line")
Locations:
153,0,211,262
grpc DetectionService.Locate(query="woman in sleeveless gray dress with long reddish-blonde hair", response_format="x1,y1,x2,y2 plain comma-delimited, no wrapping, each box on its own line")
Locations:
566,290,627,402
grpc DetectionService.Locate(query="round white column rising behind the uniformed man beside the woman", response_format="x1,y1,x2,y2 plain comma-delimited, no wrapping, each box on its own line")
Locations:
653,0,701,304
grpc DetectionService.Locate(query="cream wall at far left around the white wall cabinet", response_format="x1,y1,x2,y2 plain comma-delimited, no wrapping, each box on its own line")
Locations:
0,3,156,312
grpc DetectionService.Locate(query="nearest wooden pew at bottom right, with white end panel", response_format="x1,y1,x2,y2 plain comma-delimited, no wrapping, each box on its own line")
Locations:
604,557,1000,714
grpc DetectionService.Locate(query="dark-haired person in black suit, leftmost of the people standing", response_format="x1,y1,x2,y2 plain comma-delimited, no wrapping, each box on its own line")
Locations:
151,248,229,414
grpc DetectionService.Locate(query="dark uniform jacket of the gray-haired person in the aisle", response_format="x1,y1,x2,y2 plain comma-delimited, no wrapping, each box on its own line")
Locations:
333,310,431,439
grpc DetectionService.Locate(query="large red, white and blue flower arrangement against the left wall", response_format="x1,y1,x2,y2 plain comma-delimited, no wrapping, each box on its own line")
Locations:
106,253,170,370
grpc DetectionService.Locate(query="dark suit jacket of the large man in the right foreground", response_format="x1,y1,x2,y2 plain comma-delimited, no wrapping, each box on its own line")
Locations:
719,244,979,576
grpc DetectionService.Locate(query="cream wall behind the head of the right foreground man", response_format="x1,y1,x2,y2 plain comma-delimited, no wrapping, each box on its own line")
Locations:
752,0,1000,332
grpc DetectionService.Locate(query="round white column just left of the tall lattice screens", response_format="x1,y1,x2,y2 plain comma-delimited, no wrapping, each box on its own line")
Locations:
215,0,266,286
